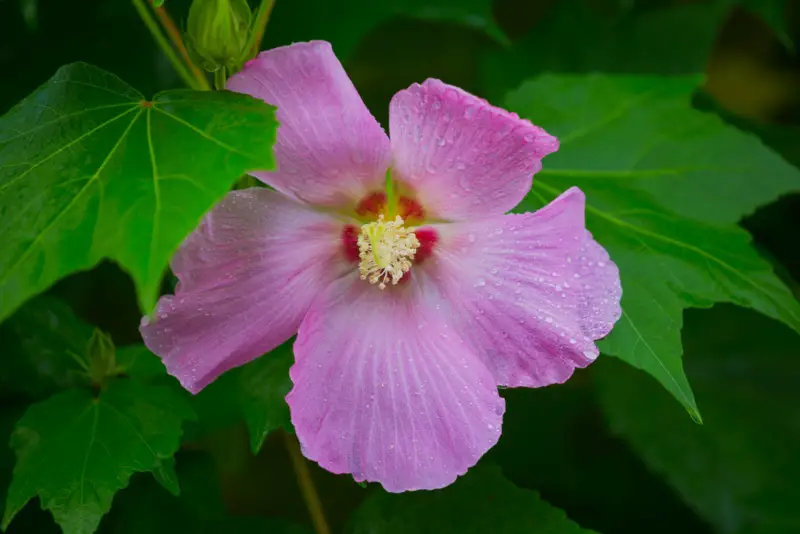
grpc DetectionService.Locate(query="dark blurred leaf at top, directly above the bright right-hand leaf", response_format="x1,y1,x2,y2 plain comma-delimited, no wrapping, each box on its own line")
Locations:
482,0,728,99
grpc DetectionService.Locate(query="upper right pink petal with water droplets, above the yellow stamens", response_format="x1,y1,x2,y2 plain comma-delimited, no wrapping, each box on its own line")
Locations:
389,79,558,220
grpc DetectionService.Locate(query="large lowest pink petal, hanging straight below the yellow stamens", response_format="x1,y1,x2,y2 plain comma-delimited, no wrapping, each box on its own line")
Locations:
287,276,505,492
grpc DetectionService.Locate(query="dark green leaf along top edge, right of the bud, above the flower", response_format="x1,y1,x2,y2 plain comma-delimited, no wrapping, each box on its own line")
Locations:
265,0,510,60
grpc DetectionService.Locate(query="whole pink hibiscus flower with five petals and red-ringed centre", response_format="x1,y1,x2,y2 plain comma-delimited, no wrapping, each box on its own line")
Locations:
141,42,621,492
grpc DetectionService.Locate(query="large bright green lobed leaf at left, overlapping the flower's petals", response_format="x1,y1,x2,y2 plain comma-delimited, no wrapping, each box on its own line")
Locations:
0,63,277,320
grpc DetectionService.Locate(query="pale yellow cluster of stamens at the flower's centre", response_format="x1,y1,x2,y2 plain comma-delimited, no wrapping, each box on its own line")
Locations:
358,215,419,289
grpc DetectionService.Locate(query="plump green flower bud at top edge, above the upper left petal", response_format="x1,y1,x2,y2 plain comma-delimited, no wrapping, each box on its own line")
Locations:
188,0,251,72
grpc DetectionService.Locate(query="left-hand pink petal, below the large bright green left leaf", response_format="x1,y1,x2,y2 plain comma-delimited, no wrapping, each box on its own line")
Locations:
140,188,352,393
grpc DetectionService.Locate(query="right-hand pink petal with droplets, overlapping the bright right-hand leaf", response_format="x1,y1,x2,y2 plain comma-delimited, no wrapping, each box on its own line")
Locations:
423,188,622,387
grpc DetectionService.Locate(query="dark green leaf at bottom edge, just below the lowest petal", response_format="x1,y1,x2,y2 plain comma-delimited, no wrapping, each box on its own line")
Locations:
346,466,591,534
